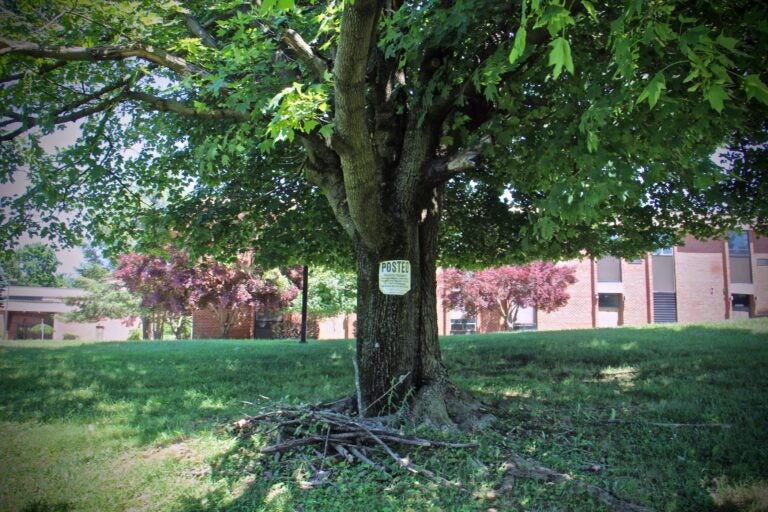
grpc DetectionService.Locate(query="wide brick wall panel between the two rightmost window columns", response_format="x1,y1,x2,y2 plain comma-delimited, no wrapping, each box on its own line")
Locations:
675,240,726,323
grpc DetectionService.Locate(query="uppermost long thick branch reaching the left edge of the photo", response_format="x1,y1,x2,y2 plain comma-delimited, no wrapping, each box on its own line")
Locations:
0,38,206,75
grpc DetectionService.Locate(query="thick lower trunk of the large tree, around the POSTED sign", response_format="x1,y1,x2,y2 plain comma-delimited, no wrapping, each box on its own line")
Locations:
357,198,490,429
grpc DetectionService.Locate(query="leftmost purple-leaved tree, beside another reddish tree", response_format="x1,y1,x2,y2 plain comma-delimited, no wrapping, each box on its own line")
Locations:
113,251,195,339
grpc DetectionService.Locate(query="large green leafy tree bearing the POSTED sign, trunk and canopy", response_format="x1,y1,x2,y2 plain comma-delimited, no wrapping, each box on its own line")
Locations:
0,0,768,423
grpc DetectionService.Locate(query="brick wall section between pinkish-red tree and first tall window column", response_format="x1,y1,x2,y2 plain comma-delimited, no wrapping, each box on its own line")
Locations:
538,259,594,331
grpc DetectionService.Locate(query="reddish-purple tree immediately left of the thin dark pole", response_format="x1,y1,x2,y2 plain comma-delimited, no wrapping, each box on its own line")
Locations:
191,257,299,338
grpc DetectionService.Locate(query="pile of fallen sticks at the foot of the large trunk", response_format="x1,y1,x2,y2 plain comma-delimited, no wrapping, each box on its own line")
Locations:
234,405,478,487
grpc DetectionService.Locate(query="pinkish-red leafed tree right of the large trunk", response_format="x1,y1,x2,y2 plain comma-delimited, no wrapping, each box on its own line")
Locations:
442,261,576,329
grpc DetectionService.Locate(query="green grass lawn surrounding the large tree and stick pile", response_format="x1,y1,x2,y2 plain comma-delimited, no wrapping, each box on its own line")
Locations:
0,320,768,512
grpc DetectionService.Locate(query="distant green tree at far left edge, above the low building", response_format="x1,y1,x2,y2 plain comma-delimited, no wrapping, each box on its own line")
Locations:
0,242,64,287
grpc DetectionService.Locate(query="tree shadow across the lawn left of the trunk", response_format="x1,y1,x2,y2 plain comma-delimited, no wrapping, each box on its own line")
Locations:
0,340,352,442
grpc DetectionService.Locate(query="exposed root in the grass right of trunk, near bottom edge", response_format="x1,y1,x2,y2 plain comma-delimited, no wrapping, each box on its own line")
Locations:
498,455,651,512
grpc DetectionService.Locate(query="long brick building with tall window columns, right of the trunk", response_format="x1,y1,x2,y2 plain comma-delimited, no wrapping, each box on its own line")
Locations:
439,231,768,334
